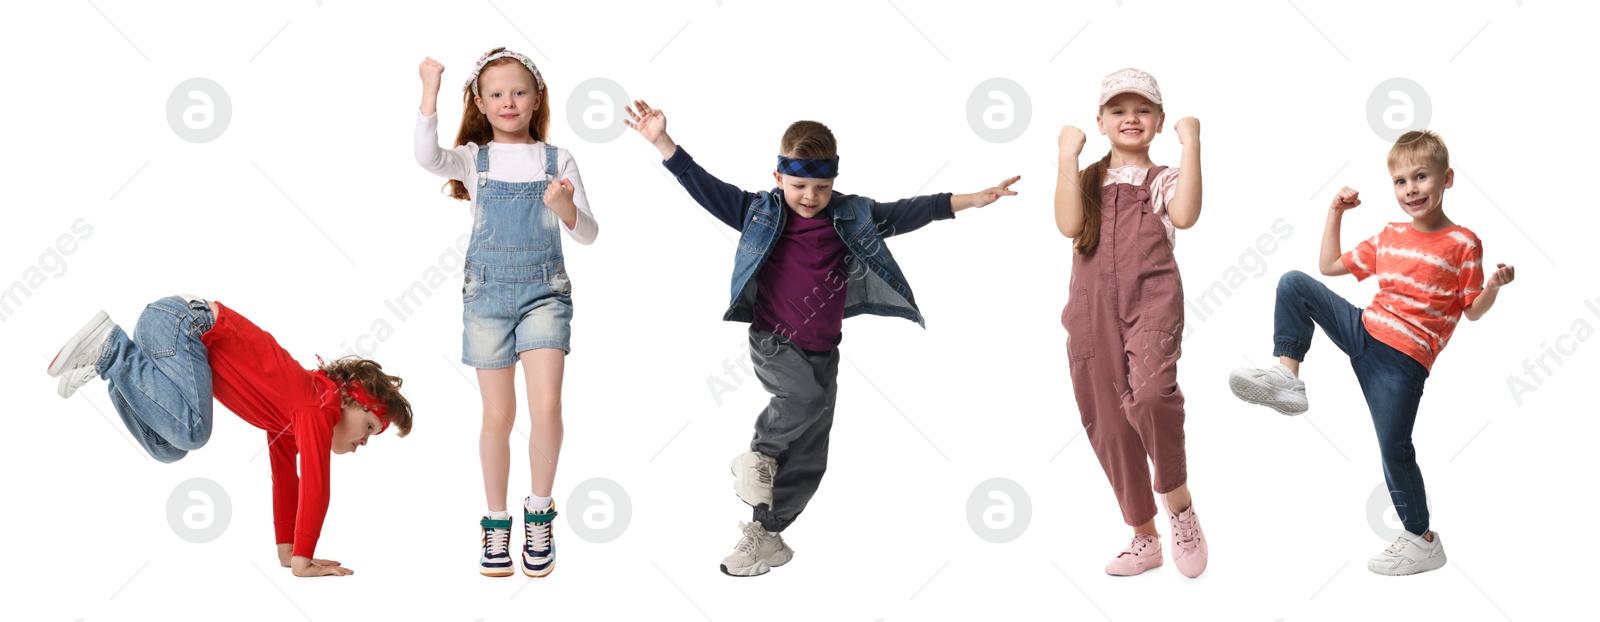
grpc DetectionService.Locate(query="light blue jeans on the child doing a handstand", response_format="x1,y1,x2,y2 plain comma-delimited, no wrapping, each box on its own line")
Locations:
94,296,214,462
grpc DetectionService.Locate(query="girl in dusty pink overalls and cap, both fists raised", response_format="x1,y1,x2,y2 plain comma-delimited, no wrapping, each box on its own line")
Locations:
1056,69,1208,577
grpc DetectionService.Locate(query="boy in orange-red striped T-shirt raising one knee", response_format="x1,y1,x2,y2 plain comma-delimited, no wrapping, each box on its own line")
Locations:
1227,131,1515,576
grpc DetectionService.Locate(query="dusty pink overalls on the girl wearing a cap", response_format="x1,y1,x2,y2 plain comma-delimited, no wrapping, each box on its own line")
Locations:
1061,166,1187,526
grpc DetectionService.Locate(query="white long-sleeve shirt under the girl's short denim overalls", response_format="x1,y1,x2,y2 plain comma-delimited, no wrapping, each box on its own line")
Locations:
414,110,600,245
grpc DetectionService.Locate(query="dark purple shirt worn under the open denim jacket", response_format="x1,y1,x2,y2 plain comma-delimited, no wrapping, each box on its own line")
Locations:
750,208,848,352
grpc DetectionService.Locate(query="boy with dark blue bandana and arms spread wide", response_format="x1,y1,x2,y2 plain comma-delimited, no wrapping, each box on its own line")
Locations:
627,101,1021,577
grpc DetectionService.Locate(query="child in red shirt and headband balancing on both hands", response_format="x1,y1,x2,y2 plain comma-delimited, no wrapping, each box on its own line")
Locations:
48,296,411,577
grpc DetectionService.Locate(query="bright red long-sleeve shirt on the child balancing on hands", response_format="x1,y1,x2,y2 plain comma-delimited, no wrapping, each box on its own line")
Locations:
200,302,344,558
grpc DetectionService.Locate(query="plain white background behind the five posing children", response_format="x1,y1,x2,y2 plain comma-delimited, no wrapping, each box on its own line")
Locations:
0,0,1600,622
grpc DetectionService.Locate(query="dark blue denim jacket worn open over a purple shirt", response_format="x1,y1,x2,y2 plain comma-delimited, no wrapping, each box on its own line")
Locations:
664,146,955,328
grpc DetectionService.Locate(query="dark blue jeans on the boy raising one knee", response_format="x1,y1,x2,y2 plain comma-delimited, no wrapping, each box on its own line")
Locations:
1272,270,1427,536
